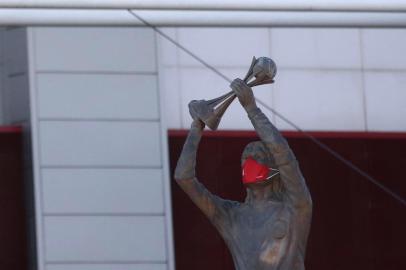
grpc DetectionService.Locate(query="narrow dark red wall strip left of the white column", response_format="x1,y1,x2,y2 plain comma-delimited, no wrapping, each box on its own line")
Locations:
0,127,28,270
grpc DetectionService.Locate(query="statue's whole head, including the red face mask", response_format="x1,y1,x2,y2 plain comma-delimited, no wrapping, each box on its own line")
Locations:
241,141,282,197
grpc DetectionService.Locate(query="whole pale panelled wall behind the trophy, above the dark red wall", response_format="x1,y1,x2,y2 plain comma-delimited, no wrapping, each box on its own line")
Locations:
159,28,406,131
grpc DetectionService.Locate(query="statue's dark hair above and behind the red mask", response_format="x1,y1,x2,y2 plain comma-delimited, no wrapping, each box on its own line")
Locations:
241,141,284,200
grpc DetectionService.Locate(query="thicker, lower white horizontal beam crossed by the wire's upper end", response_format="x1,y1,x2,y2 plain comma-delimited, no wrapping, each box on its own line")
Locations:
0,9,406,27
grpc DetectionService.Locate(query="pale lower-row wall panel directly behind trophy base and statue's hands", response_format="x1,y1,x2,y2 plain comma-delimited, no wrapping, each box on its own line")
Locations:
181,67,273,129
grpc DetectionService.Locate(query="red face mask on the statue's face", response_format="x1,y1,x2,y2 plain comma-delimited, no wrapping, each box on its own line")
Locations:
242,156,279,184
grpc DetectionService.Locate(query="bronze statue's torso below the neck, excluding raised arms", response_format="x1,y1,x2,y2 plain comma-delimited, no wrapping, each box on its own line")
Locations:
215,202,307,270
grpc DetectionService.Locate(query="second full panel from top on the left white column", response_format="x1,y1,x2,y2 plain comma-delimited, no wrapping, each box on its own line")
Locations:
37,74,159,120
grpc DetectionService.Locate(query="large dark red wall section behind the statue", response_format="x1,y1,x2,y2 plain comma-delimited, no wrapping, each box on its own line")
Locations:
169,131,406,270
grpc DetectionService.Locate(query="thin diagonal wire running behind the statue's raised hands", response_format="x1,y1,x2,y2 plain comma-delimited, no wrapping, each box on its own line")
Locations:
128,9,406,206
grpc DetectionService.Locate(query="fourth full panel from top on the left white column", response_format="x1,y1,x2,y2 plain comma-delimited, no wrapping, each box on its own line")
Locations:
42,169,164,214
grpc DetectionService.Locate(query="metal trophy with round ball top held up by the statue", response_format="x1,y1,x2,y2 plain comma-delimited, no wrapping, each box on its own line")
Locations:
189,57,276,130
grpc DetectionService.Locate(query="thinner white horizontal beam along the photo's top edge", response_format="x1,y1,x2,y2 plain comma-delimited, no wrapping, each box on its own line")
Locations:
0,0,406,12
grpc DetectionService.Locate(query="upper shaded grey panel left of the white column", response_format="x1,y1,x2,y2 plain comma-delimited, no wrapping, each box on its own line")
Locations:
4,27,28,74
